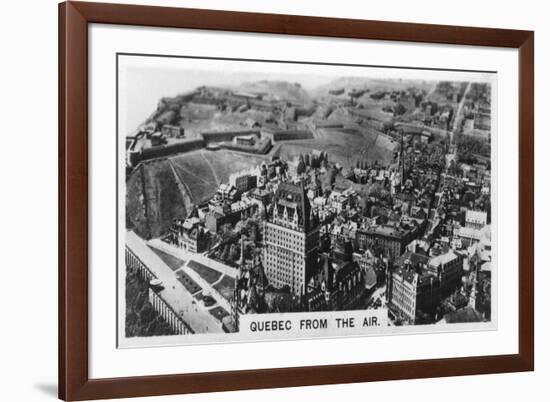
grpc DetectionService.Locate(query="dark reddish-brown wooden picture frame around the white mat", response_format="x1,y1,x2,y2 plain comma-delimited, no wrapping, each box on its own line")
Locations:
59,1,534,400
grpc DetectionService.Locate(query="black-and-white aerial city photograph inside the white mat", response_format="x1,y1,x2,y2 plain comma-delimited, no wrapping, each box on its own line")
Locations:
117,56,496,344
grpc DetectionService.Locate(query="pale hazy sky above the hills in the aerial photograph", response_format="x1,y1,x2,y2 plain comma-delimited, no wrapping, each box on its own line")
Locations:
119,56,495,135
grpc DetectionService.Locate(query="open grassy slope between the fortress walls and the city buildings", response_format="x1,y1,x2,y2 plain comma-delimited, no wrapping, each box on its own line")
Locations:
126,126,396,239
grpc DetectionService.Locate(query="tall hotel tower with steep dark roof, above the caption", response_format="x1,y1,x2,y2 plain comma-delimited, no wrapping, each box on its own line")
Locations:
264,182,319,295
